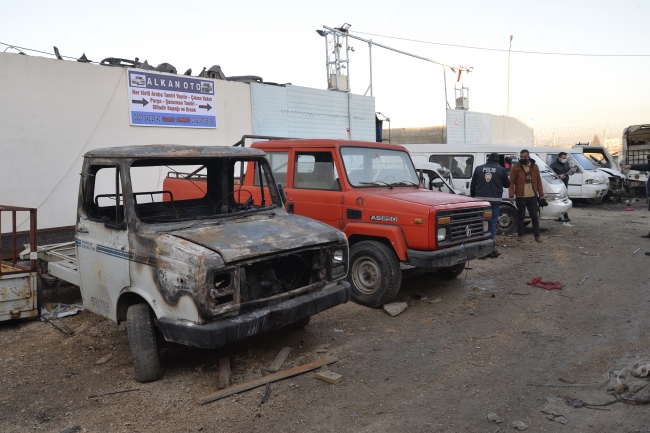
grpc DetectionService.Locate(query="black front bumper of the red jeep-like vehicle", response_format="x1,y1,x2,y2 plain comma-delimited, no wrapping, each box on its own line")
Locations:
406,239,495,268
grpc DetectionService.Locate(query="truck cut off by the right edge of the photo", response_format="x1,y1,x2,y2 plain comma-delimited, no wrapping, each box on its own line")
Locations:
621,124,650,197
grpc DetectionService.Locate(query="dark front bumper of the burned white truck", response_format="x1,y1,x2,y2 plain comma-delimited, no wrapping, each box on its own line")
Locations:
158,281,351,349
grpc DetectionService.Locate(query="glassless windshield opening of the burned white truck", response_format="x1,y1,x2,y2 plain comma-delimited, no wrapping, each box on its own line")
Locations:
126,157,280,223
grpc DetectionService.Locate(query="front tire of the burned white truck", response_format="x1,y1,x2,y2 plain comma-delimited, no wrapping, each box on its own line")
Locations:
126,304,165,383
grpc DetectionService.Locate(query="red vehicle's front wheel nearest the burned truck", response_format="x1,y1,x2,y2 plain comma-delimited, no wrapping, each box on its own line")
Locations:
348,241,402,308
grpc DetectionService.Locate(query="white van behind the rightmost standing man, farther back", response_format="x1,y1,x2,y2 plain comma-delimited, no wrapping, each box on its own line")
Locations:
528,146,622,203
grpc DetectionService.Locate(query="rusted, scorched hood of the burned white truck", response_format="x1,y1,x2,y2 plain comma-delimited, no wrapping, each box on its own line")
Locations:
170,214,345,263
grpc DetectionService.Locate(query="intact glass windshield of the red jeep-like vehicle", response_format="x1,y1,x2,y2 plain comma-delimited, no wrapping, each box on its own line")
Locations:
341,147,420,188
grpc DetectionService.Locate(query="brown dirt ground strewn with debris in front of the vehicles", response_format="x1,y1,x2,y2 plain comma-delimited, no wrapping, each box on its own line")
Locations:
0,202,650,432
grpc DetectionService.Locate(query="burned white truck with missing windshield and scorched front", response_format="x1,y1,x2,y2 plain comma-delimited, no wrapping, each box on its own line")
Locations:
33,146,350,382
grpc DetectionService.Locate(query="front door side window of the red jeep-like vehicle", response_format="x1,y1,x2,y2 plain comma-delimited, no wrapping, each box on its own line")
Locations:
293,152,341,191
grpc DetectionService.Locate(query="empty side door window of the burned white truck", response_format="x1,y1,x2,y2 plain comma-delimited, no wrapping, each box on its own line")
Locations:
84,165,124,224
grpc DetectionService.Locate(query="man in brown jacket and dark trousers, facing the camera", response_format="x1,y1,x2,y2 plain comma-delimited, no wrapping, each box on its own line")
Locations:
509,149,545,243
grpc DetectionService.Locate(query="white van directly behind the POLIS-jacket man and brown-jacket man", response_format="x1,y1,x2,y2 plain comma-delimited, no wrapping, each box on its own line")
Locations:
403,144,573,234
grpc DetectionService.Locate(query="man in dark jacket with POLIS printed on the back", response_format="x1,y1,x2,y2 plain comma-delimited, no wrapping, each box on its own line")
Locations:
469,153,510,246
